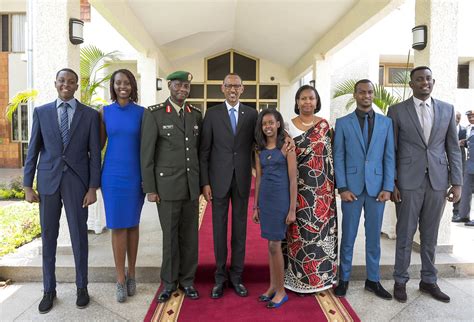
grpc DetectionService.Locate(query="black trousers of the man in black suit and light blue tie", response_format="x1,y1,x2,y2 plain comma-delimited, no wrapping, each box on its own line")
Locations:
212,173,248,284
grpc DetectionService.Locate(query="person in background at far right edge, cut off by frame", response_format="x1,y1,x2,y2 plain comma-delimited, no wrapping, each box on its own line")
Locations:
458,111,474,226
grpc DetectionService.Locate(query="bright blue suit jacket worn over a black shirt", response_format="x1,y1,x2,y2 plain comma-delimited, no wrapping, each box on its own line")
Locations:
334,112,395,197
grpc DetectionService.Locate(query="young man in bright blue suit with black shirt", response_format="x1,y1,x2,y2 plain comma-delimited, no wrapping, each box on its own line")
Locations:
334,79,395,300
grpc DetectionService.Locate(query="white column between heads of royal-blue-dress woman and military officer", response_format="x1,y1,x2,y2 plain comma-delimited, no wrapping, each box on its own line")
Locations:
137,53,158,106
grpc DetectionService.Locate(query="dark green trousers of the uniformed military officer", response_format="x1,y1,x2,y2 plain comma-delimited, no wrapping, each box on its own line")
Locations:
158,199,199,290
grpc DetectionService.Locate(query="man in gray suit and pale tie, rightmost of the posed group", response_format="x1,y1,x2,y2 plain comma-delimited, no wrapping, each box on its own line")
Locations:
388,66,462,302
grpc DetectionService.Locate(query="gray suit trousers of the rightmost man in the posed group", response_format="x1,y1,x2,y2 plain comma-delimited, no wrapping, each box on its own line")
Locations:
393,175,446,283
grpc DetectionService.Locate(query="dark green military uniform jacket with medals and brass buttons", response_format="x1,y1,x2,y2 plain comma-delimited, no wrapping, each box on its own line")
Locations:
140,100,202,200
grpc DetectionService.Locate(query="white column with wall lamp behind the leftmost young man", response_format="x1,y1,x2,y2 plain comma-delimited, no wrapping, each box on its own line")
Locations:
30,0,80,106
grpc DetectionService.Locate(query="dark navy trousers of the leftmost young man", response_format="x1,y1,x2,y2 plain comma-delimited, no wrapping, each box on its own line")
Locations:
39,169,89,292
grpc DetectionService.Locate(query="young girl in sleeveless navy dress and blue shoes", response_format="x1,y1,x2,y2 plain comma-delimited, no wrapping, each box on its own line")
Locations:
253,109,297,309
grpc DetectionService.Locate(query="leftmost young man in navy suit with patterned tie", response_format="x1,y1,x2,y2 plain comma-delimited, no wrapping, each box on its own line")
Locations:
23,68,100,313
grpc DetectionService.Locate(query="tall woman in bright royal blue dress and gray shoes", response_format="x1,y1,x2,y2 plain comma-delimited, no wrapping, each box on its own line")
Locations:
100,69,144,302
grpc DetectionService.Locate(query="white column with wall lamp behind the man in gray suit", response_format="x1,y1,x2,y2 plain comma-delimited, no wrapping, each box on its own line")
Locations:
415,0,458,251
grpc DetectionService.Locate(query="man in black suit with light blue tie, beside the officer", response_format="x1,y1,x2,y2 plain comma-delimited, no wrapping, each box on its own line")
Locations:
199,74,257,299
